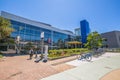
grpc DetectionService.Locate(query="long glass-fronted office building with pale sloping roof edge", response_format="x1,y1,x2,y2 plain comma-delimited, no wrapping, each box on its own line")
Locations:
0,11,74,45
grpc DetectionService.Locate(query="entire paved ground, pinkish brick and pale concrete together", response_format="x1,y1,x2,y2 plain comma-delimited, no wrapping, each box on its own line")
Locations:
0,53,120,80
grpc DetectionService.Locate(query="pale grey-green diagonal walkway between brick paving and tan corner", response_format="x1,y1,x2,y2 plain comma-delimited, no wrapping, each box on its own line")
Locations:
42,53,120,80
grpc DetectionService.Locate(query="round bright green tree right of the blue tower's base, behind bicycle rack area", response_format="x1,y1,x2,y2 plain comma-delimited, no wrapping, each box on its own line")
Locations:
85,31,102,49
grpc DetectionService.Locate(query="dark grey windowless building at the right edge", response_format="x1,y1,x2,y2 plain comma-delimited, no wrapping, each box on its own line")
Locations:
101,31,120,48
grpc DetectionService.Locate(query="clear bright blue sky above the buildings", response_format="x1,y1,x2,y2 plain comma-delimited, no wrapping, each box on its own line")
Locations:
0,0,120,33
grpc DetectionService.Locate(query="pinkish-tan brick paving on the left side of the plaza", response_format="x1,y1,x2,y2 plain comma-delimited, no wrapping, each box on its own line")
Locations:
0,54,74,80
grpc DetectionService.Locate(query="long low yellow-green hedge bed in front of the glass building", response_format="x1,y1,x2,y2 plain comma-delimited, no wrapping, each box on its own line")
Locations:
48,48,88,59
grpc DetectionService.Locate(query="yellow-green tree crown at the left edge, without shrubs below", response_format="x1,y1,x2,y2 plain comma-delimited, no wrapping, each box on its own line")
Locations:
0,17,14,40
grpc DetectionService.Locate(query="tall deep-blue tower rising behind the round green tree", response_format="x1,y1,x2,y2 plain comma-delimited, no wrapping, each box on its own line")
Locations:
80,20,90,44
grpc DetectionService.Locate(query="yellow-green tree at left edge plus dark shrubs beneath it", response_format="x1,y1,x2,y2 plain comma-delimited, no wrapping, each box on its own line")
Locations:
0,17,14,50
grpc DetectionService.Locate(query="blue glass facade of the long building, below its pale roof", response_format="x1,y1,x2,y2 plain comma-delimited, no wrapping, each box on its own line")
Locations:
10,20,71,44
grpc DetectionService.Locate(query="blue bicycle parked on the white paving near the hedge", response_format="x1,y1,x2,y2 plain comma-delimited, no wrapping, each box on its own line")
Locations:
77,53,92,62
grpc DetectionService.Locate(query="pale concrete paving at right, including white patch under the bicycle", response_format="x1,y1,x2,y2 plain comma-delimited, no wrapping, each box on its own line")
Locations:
42,53,120,80
